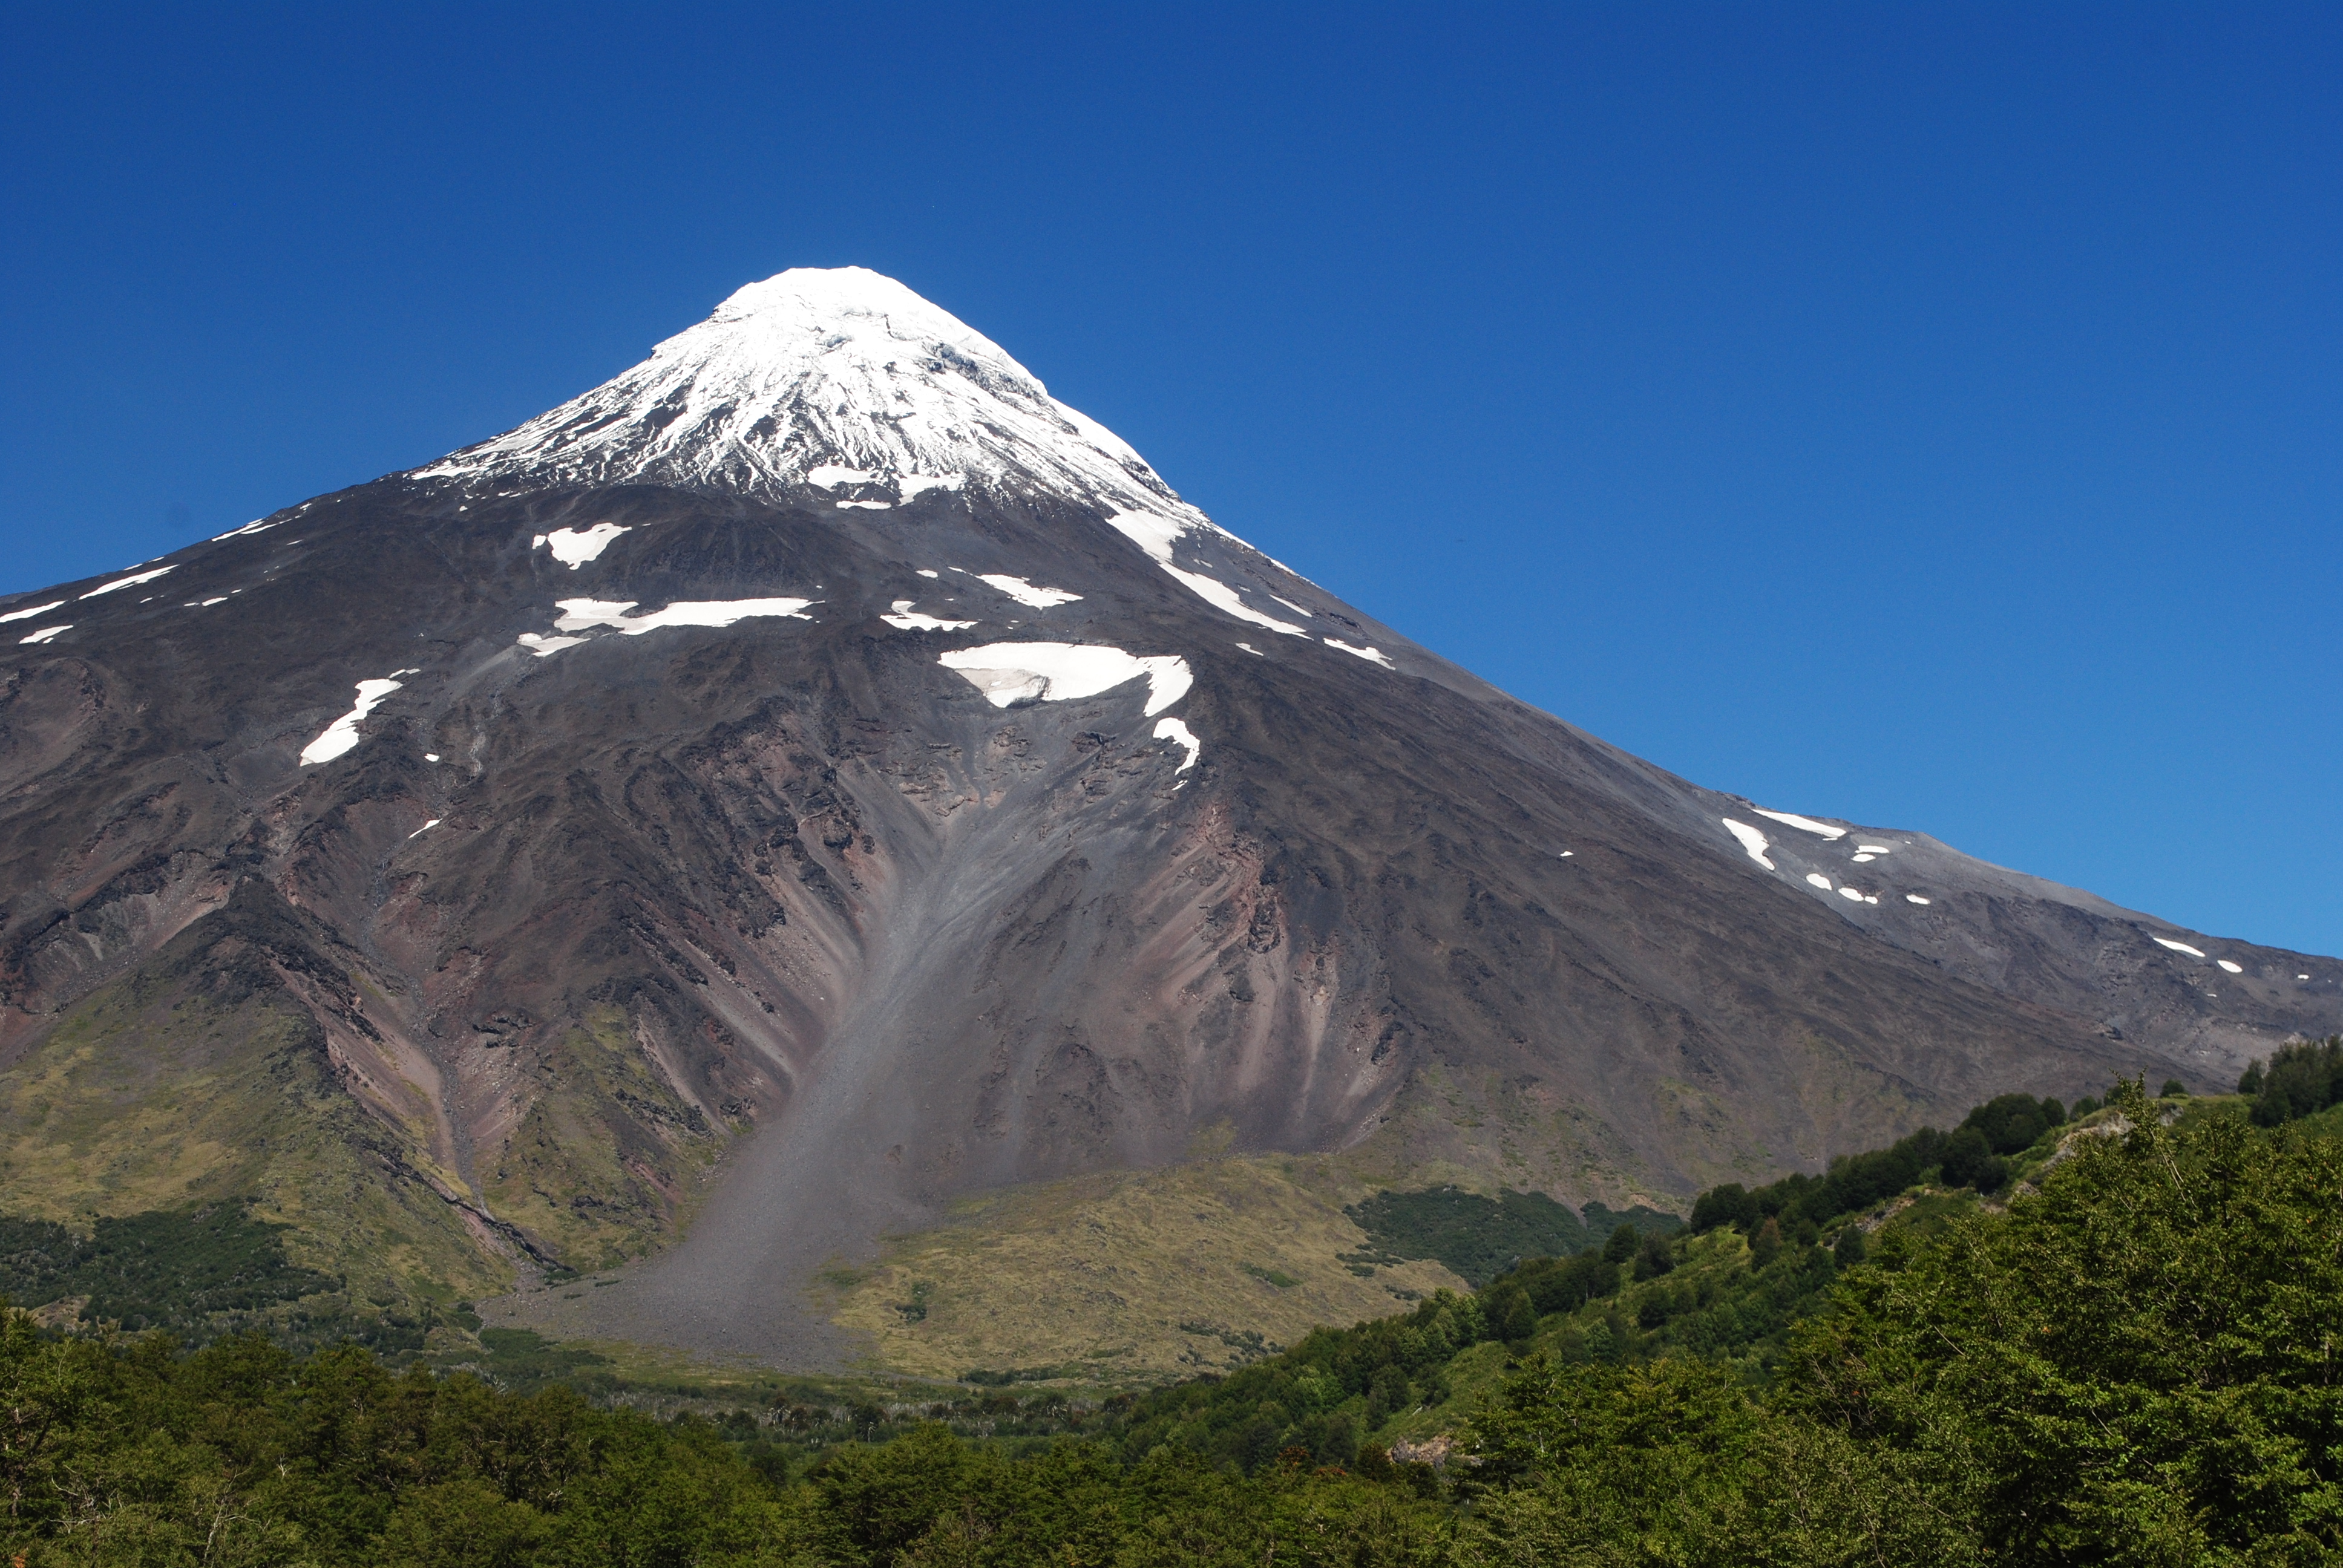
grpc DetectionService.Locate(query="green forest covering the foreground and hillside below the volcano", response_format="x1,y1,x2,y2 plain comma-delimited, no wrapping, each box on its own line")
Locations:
0,1078,2343,1568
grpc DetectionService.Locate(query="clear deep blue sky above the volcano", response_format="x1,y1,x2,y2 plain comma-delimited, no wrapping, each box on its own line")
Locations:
0,5,2343,954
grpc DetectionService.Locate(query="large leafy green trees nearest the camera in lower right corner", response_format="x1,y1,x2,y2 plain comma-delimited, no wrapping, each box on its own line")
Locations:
1783,1083,2343,1563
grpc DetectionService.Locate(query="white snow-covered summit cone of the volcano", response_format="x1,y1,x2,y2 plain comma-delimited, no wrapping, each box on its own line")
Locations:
415,267,1202,523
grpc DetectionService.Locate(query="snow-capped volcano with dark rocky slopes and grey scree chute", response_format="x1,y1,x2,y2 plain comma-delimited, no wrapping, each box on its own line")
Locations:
0,274,2343,1354
